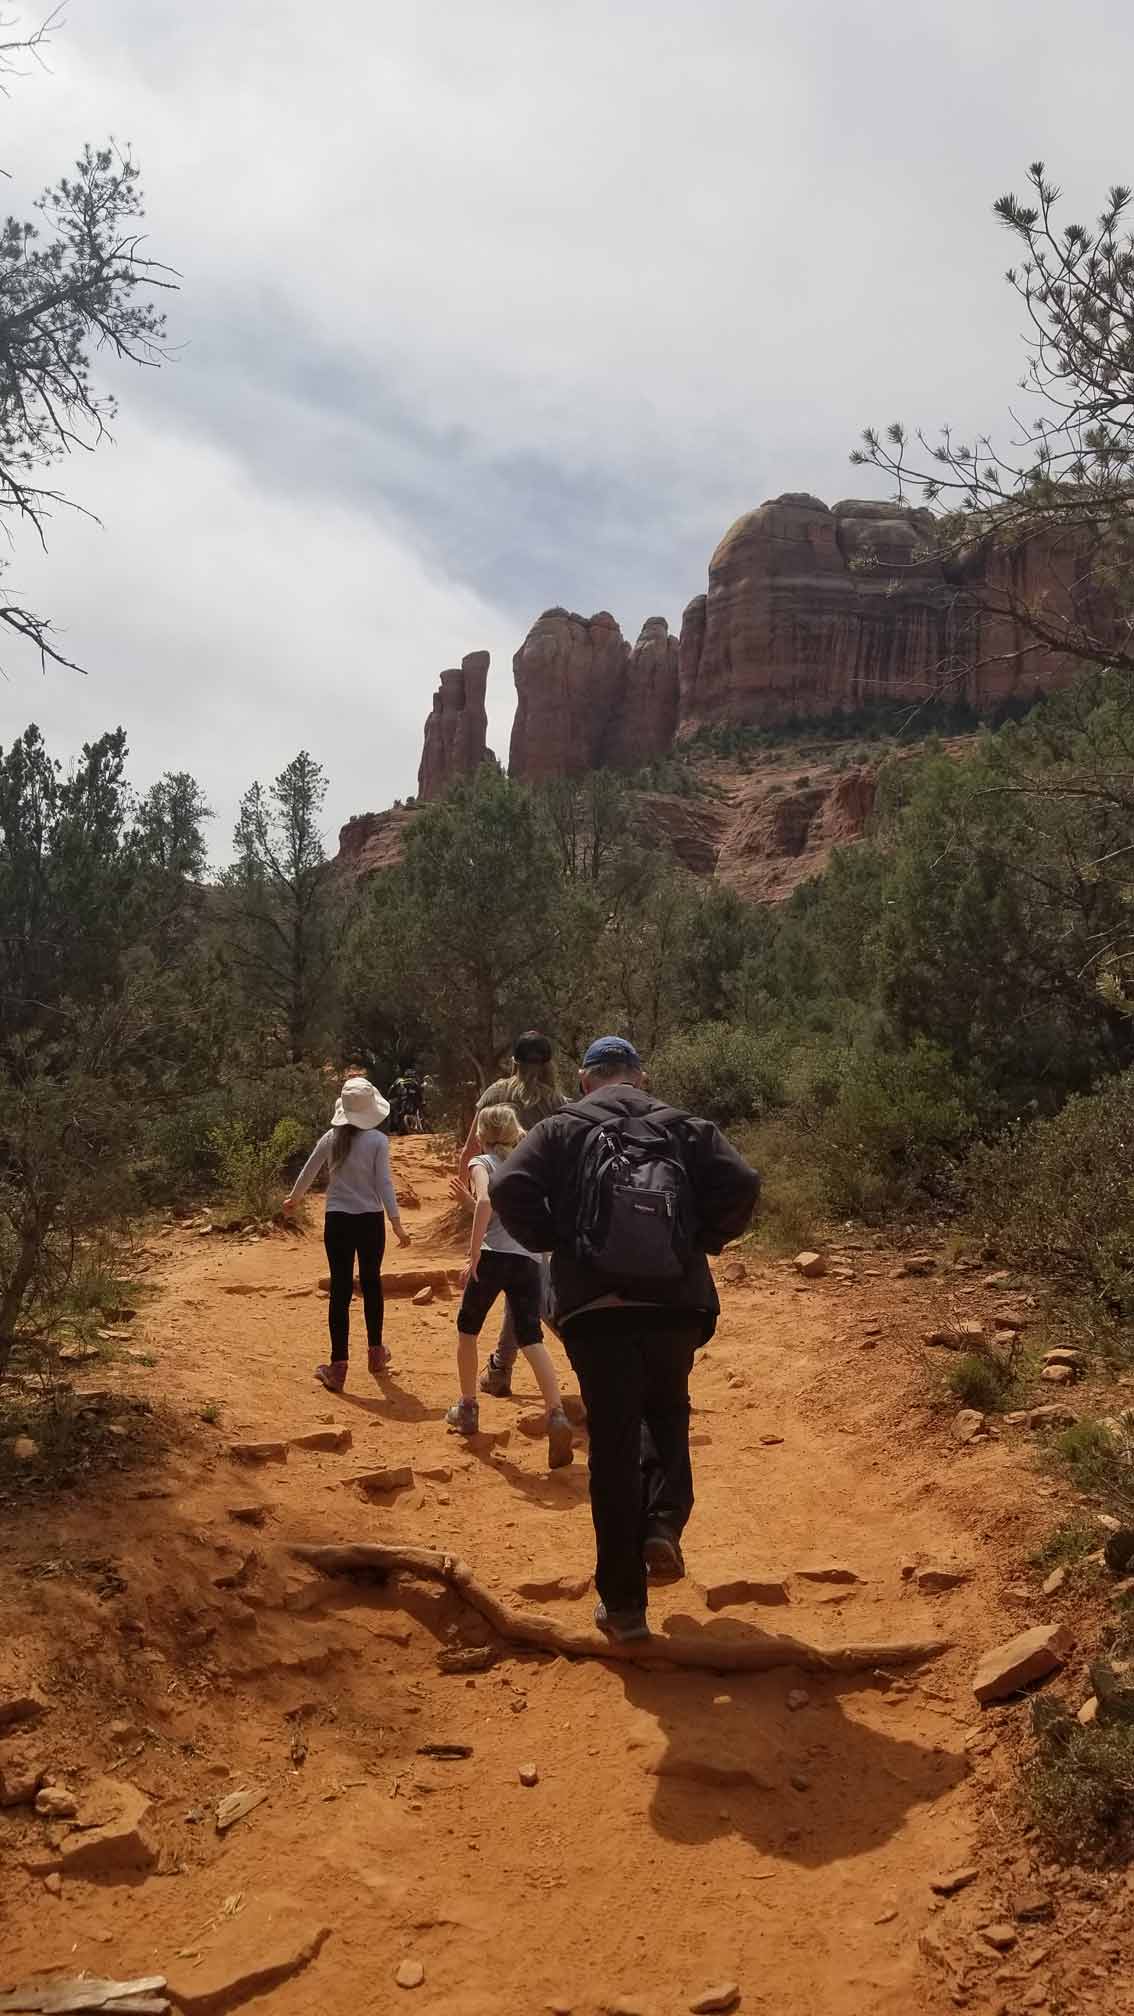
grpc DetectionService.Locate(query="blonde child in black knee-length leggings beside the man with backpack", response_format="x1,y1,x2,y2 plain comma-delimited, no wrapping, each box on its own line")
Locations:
446,1107,575,1470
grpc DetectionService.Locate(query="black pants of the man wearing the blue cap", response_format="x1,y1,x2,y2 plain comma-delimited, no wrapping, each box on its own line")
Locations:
563,1308,704,1611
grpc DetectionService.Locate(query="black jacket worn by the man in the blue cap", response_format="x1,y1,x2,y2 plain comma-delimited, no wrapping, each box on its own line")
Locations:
488,1085,761,1339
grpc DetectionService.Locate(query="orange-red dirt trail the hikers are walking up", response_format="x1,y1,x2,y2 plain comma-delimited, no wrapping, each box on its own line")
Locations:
0,1141,1132,2016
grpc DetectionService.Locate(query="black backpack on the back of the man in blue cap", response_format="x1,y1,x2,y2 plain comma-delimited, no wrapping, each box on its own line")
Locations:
575,1107,696,1282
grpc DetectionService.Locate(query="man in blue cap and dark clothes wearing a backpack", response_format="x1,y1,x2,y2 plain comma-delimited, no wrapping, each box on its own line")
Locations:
488,1036,761,1643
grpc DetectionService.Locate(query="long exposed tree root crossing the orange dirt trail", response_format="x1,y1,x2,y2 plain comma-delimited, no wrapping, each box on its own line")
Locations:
289,1542,948,1673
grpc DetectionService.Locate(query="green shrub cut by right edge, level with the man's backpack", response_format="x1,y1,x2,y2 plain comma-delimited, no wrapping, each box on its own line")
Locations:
967,1070,1134,1320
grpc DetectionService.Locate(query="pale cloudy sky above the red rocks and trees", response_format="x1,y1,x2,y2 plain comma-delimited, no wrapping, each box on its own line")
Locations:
0,0,1134,859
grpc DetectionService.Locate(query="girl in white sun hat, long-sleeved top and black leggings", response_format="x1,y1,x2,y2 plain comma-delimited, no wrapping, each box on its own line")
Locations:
285,1079,410,1393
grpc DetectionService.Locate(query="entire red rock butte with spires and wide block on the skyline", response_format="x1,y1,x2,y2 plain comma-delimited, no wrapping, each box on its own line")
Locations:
409,492,1084,798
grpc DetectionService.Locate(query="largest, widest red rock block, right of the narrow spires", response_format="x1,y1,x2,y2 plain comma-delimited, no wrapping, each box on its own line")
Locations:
678,492,1071,736
